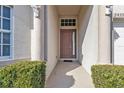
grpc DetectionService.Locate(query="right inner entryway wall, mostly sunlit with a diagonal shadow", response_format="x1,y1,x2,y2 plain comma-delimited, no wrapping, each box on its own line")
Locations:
79,6,98,74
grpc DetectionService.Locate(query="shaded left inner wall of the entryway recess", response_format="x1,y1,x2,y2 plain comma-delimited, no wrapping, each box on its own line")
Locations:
46,6,59,78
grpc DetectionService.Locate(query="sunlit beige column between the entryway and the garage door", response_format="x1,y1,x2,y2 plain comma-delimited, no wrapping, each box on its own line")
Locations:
98,6,111,64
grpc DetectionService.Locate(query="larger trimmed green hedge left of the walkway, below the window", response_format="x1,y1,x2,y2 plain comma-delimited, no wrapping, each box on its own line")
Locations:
0,61,46,88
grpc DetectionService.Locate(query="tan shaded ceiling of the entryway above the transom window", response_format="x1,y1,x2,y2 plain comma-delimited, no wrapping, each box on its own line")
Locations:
56,5,81,16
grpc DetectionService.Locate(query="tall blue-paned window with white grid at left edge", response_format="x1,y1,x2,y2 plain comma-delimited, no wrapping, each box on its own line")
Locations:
0,5,12,58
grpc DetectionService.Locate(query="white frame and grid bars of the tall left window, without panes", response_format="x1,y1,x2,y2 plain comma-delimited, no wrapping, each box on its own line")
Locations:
0,5,13,61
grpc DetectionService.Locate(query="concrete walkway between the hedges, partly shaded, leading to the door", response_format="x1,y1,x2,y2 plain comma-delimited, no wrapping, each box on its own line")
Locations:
46,62,93,88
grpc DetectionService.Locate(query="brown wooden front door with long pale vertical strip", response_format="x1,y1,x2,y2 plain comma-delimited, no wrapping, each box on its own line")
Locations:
60,29,76,58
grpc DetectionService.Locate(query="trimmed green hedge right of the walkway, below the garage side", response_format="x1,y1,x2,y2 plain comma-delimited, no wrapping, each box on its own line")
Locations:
91,65,124,88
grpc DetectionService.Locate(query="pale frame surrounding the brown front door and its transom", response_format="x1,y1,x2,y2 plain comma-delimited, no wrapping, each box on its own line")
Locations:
59,17,78,61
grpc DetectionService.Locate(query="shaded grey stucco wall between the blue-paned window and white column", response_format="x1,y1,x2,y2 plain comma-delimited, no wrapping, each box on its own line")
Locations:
13,5,33,60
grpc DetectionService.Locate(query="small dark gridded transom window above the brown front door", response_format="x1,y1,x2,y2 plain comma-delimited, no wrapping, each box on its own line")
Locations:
60,18,76,26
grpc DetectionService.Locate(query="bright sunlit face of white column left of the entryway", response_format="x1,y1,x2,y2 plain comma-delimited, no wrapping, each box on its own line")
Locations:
31,5,41,60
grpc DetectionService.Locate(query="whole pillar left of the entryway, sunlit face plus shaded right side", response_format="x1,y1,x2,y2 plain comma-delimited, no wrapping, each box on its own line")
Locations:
31,6,44,61
